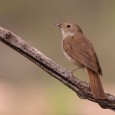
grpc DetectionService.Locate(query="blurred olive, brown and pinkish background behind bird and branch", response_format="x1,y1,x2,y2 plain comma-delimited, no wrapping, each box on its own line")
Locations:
0,0,115,115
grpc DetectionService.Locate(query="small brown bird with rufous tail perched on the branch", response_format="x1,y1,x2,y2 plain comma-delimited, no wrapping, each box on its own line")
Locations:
56,22,105,99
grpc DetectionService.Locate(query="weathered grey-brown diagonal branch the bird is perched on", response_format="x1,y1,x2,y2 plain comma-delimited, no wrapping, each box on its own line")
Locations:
0,27,115,111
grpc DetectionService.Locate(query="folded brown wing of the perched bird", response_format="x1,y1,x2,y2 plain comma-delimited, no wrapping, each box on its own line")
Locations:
63,35,102,74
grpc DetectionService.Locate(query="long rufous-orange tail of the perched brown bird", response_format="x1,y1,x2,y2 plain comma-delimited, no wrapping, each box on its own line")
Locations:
86,68,105,99
